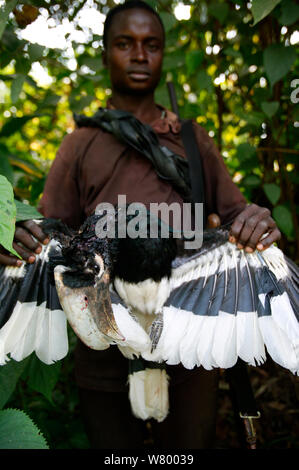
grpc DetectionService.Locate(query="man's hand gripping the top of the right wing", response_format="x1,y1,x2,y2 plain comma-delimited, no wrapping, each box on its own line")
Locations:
229,204,281,253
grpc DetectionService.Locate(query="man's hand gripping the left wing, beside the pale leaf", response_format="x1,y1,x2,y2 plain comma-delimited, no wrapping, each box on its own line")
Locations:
0,220,50,266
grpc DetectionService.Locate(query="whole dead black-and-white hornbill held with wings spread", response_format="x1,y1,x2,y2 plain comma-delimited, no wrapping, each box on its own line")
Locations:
0,214,299,421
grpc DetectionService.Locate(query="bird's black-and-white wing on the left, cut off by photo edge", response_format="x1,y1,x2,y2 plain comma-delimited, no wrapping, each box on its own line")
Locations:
0,239,68,365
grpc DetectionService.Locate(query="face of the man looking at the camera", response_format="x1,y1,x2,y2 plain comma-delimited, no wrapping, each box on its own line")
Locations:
103,9,164,95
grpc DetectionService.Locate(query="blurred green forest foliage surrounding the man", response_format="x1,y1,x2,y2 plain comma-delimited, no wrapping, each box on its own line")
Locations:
0,0,299,449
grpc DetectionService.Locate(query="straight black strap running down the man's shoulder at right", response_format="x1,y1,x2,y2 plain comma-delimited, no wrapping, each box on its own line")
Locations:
181,119,206,222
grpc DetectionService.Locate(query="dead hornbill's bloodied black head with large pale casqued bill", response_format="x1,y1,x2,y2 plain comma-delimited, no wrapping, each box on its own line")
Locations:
46,216,125,349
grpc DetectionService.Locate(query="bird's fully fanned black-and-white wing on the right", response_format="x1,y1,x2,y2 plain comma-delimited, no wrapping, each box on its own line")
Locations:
143,237,299,373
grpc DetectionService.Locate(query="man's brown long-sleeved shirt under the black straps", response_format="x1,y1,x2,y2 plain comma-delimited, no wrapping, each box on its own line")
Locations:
40,111,246,392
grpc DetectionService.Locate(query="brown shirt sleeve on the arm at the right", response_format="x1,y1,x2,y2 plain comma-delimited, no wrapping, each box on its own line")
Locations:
193,123,247,224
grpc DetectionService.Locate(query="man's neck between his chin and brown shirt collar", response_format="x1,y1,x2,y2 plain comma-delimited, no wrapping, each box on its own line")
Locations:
110,93,161,124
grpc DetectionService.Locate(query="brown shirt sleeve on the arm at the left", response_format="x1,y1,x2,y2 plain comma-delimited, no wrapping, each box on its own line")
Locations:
39,131,83,228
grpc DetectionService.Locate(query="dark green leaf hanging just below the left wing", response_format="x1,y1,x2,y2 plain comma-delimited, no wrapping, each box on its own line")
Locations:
28,355,61,404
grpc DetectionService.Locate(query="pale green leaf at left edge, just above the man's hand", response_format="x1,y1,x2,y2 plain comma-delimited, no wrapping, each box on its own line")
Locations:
0,175,20,258
